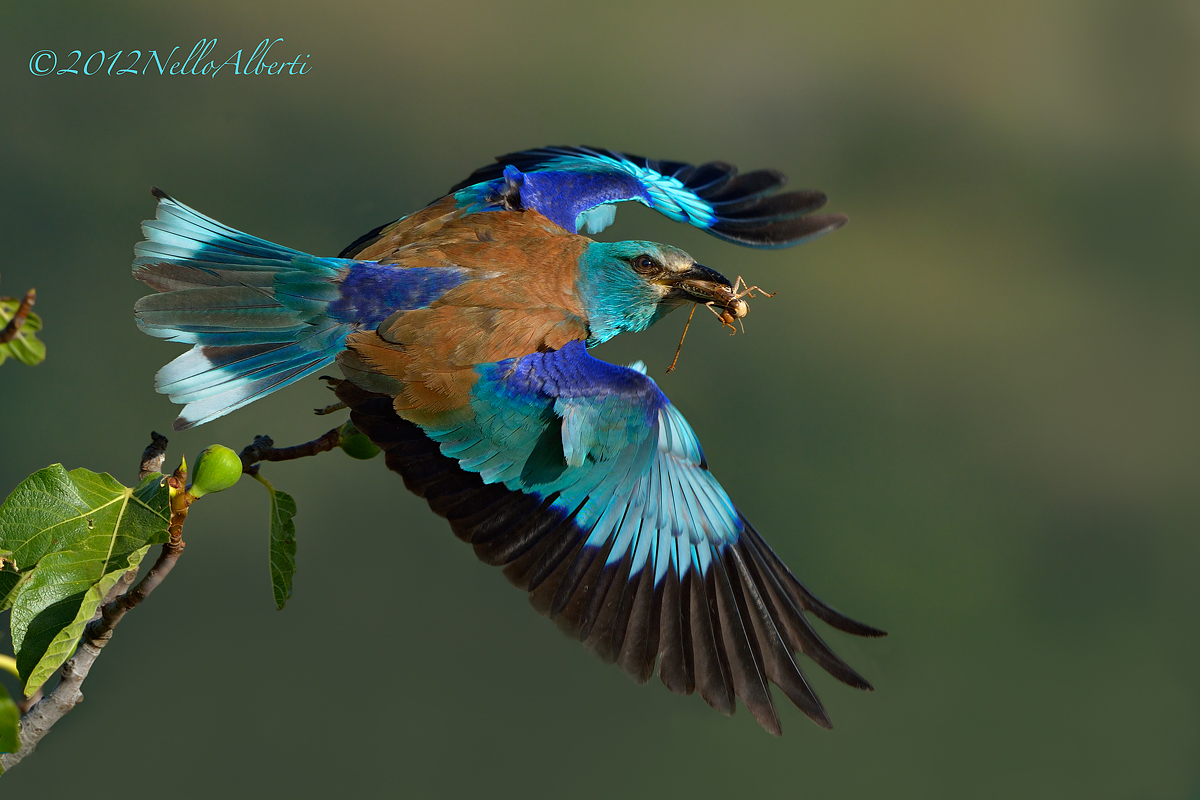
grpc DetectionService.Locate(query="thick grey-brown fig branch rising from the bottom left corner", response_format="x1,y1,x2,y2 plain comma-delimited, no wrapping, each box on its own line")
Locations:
0,433,192,770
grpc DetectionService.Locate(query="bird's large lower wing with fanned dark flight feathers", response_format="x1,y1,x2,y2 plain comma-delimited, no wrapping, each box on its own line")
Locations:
338,341,883,735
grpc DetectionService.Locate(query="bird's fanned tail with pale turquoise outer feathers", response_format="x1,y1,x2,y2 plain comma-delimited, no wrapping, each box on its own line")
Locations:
133,188,355,431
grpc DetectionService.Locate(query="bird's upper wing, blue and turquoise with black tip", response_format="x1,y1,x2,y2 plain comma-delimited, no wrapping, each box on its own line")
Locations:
450,148,846,247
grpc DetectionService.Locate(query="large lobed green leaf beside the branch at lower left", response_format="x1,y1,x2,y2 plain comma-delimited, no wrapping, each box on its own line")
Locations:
0,464,170,694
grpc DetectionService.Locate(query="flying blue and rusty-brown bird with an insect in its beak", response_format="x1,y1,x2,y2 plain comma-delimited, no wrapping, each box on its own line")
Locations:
133,146,886,735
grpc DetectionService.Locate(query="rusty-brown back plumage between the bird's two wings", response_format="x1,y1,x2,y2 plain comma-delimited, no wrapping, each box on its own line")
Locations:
340,206,590,422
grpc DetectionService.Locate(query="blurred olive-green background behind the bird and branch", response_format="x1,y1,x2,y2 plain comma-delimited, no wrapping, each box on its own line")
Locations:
0,0,1200,799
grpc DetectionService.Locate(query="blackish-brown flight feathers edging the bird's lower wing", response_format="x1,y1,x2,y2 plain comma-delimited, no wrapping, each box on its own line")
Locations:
338,381,884,736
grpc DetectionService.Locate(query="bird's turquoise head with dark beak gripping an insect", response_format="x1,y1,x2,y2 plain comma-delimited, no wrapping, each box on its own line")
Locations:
576,241,745,344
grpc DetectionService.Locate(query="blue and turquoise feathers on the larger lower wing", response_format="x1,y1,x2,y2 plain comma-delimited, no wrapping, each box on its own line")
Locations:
426,342,739,569
